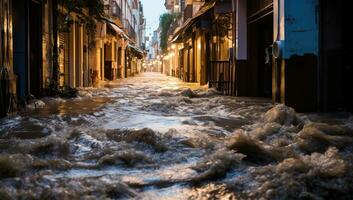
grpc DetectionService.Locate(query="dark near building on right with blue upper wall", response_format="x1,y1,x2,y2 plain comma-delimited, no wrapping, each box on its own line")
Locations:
233,0,353,112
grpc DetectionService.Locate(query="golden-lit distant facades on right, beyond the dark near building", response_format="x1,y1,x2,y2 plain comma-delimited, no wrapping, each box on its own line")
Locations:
167,0,234,89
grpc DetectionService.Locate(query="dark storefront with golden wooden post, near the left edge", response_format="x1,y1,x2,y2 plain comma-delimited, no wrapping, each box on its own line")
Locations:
12,0,52,101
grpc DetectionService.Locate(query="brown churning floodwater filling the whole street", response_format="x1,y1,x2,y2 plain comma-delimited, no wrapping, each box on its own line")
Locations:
0,73,353,199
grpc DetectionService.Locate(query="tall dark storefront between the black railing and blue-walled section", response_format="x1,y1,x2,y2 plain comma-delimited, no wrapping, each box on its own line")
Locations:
233,0,274,98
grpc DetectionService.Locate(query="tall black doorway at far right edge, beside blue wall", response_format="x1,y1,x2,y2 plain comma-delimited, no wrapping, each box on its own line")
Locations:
319,0,353,112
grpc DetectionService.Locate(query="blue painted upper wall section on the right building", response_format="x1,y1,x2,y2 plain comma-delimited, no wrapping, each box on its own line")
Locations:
283,0,319,59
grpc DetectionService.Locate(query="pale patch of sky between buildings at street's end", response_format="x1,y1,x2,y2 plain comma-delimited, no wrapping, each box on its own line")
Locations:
141,0,167,42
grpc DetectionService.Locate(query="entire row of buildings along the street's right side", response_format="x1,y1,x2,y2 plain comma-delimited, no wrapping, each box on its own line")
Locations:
163,0,353,112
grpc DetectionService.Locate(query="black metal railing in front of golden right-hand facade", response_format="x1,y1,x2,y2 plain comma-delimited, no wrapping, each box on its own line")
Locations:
208,60,235,96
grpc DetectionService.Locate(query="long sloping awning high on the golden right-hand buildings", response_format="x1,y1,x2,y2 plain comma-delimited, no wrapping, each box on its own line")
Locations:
170,0,217,43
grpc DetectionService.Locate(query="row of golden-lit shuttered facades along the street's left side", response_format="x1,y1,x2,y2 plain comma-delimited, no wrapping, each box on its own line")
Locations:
0,0,145,116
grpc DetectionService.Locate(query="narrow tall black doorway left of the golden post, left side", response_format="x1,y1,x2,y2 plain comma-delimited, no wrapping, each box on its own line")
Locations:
28,1,43,97
